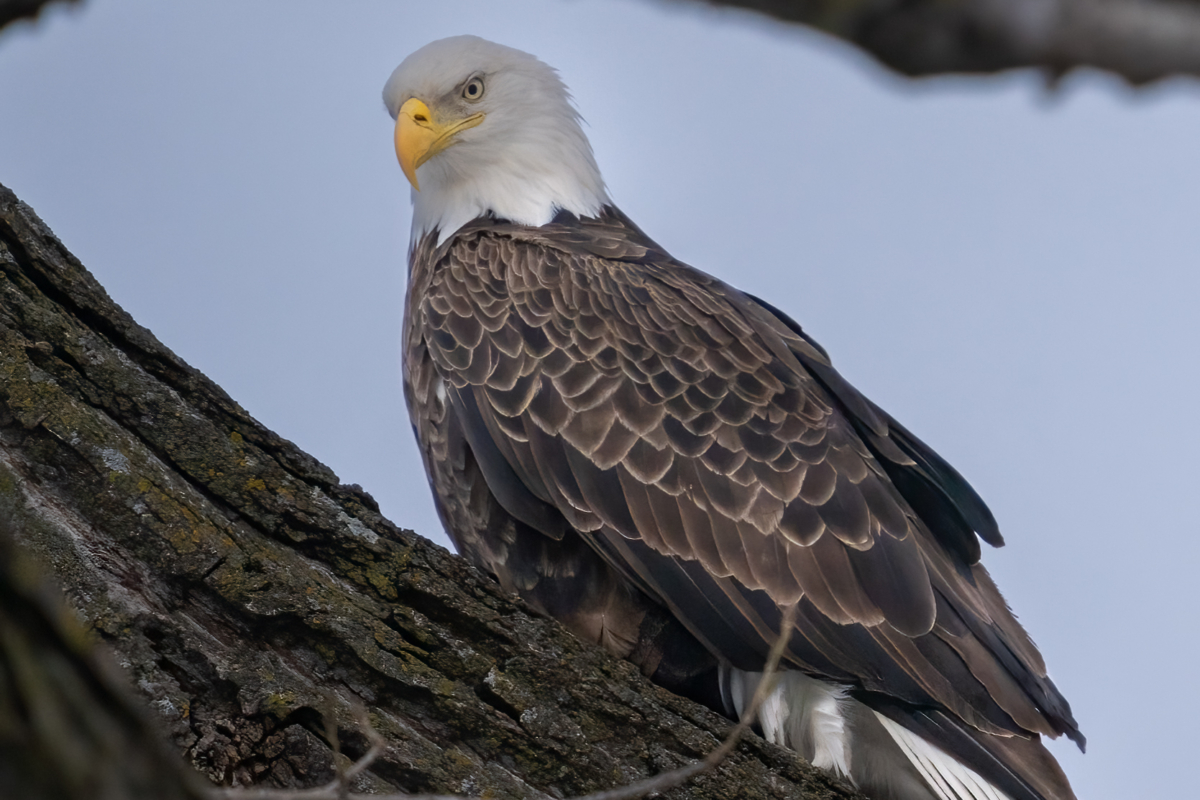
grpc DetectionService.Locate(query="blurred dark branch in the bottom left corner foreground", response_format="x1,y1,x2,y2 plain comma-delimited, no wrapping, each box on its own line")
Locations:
0,524,204,800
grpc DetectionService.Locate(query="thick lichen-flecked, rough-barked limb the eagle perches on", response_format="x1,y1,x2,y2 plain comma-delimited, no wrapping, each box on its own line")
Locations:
0,187,853,799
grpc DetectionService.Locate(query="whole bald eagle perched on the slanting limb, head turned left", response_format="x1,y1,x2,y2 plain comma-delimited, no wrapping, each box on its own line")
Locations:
384,36,1084,800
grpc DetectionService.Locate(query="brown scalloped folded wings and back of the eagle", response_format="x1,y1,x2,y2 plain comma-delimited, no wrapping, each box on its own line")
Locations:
409,211,1078,758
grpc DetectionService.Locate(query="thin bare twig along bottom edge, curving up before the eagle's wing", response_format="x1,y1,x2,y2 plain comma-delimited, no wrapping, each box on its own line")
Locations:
210,606,797,800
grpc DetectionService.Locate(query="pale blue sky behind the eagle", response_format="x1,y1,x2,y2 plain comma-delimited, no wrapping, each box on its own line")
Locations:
0,0,1200,800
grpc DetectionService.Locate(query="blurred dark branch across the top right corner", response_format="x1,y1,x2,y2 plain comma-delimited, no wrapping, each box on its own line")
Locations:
692,0,1200,84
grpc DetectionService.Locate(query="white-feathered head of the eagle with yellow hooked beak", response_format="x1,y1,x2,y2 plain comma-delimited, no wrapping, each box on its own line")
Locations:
383,36,608,241
